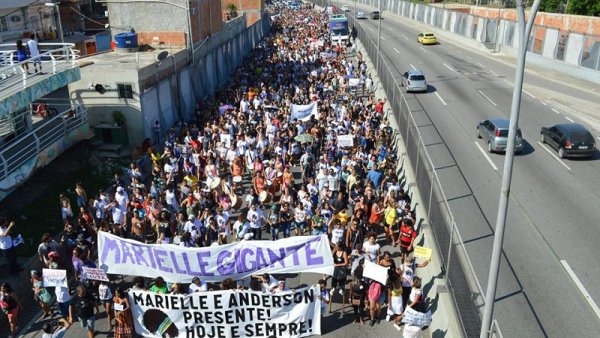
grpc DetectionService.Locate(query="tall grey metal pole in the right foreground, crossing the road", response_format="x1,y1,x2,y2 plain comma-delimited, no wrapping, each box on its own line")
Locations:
479,0,541,338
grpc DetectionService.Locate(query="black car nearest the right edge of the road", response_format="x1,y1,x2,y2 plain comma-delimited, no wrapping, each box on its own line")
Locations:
540,123,596,158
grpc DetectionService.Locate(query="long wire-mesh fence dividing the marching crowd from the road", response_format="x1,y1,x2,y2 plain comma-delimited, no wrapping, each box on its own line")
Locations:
315,0,490,337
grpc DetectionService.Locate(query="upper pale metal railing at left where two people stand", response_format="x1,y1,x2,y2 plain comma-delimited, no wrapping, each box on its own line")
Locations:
0,43,79,95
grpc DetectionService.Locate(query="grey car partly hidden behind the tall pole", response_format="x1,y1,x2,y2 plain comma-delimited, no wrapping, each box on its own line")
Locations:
476,118,523,153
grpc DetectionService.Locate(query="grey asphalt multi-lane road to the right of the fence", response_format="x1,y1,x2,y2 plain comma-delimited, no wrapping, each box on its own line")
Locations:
341,2,600,337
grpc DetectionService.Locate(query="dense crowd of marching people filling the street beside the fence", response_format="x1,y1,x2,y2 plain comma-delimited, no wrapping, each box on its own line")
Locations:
0,3,428,338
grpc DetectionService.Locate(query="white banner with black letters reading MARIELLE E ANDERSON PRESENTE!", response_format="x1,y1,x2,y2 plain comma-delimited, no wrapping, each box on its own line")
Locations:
129,287,321,338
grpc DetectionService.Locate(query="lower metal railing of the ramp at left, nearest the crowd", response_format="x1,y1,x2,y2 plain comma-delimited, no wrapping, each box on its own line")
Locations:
0,106,87,183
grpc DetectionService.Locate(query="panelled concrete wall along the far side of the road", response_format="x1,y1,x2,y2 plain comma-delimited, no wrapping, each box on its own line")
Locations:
350,0,600,83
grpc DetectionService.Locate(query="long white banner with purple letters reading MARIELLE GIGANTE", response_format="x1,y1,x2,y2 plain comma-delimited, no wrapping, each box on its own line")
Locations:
98,231,333,283
